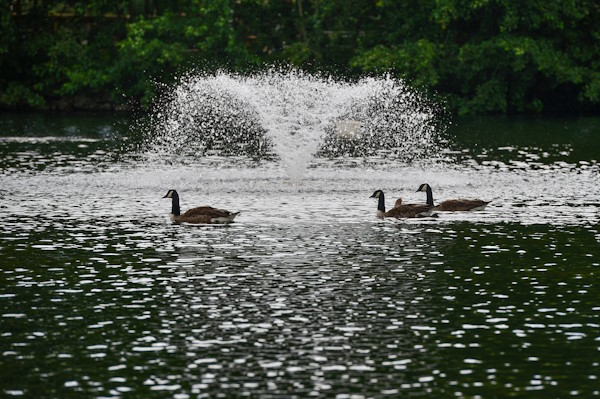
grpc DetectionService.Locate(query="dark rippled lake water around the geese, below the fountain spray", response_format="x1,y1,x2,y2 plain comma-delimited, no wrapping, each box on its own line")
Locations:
0,115,600,399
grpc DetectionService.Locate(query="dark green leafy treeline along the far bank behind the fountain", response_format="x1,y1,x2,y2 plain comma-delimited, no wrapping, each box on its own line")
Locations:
0,0,600,114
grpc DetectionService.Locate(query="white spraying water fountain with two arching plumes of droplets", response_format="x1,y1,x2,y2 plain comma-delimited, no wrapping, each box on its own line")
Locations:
145,69,439,178
